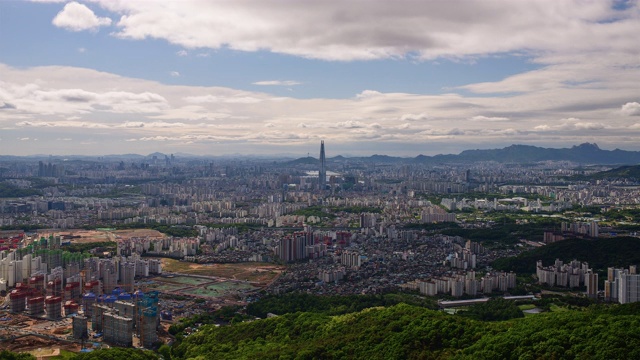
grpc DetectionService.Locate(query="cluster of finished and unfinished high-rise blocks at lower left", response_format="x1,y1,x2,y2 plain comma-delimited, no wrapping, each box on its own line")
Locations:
0,235,162,348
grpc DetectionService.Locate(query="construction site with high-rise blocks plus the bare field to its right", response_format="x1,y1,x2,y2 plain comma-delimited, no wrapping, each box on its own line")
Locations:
0,234,268,357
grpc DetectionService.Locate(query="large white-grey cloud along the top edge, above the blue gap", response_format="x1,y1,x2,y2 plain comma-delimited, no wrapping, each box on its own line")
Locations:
77,0,640,61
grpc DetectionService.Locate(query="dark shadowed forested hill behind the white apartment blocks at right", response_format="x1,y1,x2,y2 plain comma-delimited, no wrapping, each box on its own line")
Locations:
491,237,640,274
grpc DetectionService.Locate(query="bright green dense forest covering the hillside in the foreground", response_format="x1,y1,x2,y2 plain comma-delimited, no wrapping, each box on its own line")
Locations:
5,298,640,360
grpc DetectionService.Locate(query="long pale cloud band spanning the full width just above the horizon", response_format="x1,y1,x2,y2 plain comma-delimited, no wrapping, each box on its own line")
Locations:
0,64,640,155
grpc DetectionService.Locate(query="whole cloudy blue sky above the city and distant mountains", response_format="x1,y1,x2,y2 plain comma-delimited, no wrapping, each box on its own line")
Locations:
0,0,640,157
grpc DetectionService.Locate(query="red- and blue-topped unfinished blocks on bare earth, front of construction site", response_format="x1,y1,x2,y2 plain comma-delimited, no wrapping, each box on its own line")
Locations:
0,288,169,351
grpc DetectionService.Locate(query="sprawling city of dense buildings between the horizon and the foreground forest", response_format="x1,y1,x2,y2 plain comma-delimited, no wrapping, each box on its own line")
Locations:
0,143,640,348
